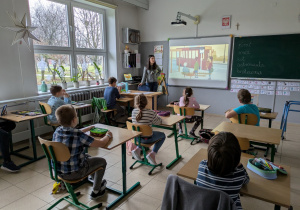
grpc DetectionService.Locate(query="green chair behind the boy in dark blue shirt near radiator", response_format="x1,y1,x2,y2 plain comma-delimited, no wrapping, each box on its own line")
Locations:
92,97,115,125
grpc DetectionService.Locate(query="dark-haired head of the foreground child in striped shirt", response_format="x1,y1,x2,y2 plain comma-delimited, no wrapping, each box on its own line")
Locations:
207,132,241,176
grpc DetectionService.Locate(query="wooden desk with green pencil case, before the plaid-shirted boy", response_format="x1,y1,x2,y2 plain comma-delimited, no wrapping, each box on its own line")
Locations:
87,124,141,209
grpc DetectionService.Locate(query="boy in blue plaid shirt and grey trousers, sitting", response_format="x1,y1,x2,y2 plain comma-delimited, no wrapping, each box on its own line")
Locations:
52,105,112,200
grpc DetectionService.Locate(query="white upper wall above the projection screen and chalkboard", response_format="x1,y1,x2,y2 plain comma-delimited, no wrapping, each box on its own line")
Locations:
139,0,300,42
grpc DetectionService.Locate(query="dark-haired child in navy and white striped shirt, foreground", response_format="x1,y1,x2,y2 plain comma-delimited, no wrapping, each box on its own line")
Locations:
196,132,249,209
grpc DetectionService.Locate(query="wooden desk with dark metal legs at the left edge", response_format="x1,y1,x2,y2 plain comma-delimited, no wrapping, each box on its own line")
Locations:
0,112,48,167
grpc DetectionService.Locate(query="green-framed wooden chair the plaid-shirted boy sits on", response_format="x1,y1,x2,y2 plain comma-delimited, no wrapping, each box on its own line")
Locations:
38,137,103,210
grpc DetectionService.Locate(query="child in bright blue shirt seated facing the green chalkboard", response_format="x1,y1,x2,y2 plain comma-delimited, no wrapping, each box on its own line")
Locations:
225,89,260,126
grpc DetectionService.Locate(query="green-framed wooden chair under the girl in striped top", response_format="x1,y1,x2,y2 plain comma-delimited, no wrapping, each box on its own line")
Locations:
126,121,162,175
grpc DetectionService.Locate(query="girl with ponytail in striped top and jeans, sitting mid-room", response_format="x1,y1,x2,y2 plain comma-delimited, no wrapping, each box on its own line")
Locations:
131,94,166,165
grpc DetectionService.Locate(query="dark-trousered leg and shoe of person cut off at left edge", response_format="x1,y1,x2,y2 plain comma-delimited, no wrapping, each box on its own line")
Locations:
0,121,20,172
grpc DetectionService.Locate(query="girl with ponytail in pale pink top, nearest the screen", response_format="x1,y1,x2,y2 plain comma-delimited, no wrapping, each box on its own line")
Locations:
178,87,203,138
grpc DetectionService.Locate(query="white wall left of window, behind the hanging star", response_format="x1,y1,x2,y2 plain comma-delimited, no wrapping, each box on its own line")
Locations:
0,0,37,101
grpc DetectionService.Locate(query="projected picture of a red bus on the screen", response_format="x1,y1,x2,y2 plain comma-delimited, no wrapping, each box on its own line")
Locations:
169,44,229,80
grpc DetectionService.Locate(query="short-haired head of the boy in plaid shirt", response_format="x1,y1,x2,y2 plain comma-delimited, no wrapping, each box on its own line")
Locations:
55,105,78,127
